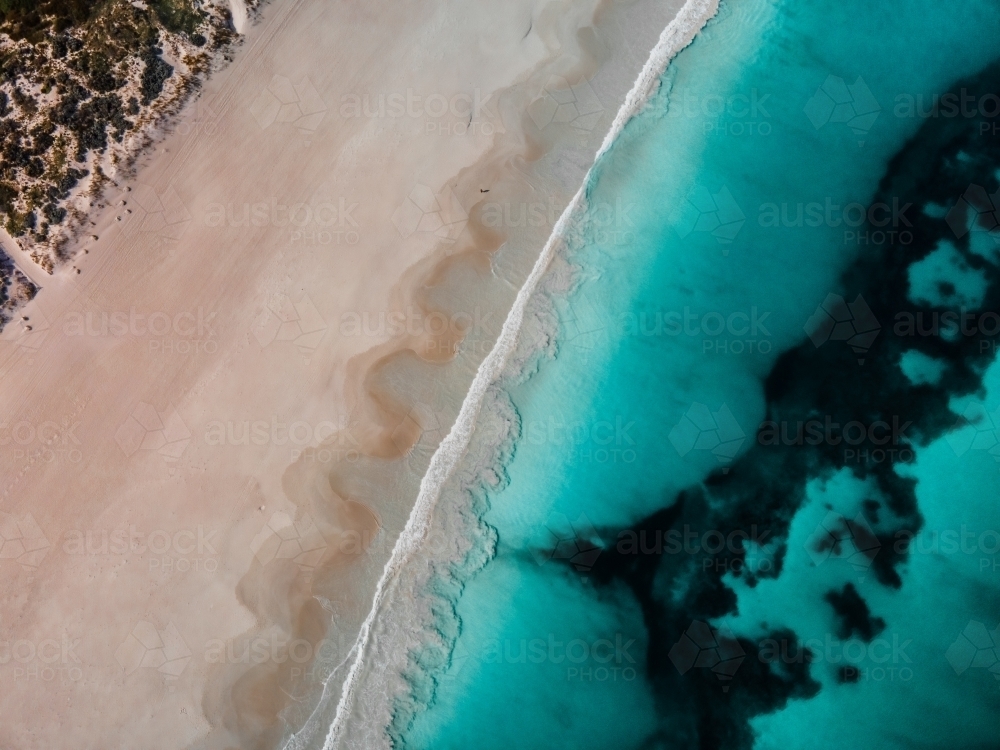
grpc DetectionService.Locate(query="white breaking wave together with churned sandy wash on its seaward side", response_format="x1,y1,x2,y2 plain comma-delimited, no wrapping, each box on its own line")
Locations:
320,0,718,748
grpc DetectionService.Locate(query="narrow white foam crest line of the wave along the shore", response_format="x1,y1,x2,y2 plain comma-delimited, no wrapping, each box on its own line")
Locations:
323,0,719,750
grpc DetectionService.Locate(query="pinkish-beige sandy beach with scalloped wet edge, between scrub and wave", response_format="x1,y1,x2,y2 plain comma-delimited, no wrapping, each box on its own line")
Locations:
0,0,696,748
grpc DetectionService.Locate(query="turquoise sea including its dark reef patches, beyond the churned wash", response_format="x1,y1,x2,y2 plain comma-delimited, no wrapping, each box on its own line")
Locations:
395,0,1000,750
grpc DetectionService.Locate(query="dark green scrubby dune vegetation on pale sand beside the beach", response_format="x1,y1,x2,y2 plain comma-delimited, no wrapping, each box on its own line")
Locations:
0,0,237,283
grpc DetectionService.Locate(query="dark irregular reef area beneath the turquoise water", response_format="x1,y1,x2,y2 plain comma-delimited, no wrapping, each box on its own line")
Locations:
544,57,1000,750
